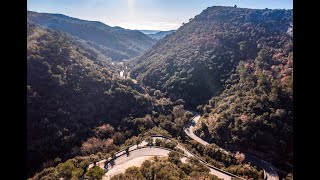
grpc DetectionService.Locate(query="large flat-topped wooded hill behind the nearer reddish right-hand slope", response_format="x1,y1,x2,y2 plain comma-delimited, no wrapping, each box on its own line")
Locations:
131,6,292,107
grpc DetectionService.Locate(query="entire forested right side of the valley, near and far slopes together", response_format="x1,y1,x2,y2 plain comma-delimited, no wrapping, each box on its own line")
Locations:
131,7,293,176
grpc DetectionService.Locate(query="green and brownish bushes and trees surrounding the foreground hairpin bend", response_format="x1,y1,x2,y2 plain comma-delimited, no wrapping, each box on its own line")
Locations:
31,113,262,180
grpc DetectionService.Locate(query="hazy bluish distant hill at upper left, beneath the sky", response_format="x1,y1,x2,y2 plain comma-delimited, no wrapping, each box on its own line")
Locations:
27,11,155,61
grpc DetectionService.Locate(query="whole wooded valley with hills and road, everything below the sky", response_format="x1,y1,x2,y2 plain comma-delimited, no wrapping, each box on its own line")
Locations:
27,6,293,180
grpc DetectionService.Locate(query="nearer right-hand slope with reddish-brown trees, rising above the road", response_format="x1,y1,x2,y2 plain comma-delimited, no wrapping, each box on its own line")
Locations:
198,43,293,169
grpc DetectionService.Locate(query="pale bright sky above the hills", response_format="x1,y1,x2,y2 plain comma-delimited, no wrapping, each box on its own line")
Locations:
27,0,293,30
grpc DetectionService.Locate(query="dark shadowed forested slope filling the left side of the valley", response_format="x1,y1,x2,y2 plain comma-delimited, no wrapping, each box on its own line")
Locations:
27,23,152,176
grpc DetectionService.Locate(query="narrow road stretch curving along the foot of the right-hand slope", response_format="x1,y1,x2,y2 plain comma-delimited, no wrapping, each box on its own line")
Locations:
184,112,279,180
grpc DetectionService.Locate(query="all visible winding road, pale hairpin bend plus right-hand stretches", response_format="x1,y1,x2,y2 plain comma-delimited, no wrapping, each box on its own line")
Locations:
88,113,279,180
